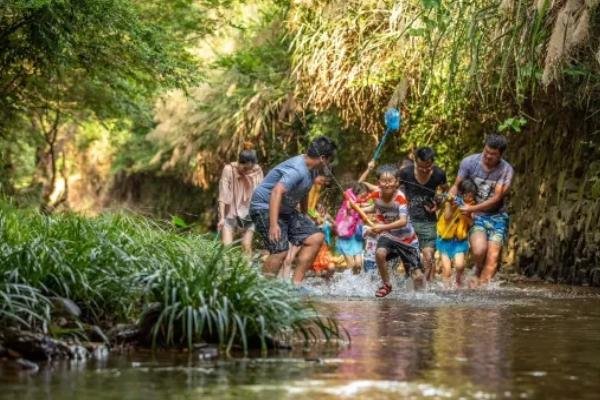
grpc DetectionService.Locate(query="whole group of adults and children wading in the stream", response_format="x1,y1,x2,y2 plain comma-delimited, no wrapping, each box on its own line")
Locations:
218,134,513,297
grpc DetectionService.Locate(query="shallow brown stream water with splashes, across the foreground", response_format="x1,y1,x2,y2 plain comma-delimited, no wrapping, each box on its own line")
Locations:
0,274,600,400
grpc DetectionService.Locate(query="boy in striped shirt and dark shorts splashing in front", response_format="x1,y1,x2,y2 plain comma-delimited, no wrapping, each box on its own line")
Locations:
364,164,424,297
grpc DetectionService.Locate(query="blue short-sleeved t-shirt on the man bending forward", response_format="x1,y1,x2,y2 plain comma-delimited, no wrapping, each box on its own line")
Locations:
250,155,316,214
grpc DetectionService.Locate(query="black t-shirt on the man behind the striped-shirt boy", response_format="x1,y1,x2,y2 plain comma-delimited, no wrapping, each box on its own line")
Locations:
399,165,448,223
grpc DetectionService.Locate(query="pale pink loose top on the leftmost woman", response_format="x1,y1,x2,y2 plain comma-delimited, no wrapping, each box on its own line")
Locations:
219,162,263,218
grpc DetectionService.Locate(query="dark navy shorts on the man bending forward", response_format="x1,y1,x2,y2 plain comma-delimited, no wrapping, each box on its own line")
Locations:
250,209,321,254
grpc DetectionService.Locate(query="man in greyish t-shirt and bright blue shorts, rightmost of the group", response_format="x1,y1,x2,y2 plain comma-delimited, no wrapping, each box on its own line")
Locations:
450,135,514,284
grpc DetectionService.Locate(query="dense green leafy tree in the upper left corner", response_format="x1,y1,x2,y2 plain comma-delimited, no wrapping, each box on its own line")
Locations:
0,0,206,205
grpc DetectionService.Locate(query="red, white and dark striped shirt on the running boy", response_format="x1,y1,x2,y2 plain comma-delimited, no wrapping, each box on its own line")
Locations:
368,190,419,248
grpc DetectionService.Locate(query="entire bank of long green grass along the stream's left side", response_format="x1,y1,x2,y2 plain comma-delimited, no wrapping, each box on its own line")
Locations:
0,202,340,350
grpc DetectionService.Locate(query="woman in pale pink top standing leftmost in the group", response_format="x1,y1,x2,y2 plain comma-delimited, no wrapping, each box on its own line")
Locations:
217,145,263,255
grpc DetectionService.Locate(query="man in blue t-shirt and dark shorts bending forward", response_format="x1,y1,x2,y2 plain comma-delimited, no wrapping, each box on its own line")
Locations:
250,136,336,284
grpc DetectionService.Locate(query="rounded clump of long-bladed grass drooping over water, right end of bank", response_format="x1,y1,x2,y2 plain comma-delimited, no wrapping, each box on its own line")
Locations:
137,236,339,349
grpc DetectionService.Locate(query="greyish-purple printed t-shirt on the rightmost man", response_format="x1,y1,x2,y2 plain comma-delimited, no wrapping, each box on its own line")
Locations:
458,153,514,217
